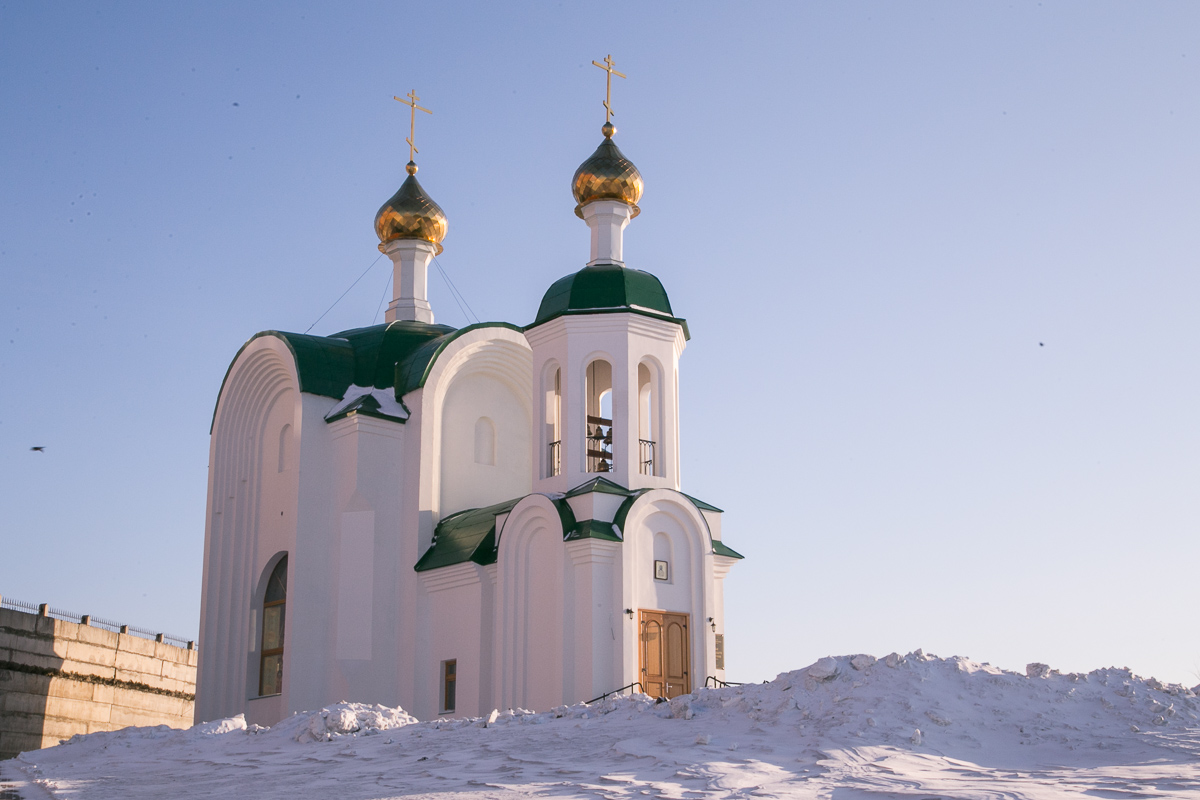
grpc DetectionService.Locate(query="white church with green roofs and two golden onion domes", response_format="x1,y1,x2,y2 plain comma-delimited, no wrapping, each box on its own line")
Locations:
196,98,742,724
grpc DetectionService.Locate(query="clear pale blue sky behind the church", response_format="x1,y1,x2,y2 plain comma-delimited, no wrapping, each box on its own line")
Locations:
0,1,1200,685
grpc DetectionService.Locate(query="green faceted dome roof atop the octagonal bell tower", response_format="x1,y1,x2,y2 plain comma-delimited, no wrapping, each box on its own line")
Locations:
529,264,691,338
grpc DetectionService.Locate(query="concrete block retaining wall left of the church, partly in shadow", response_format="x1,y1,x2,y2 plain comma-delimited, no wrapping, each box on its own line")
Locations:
0,608,197,759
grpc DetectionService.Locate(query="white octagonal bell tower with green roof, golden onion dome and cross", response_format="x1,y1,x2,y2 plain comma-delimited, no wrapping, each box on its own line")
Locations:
526,56,688,492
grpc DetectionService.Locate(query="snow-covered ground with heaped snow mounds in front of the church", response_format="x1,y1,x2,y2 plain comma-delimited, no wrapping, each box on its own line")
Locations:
0,650,1200,800
